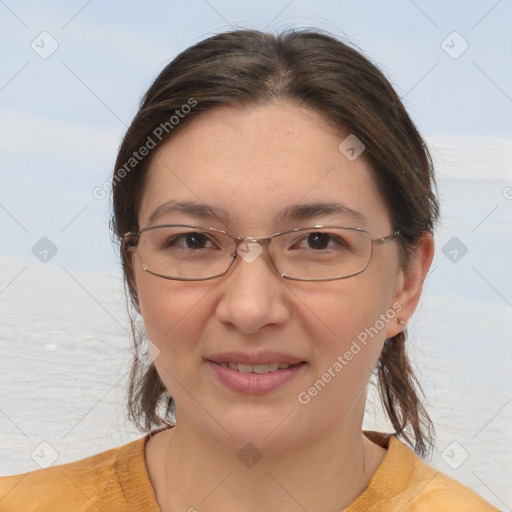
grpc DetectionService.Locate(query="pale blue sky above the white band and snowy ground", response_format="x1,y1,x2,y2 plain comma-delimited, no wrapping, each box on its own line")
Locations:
0,0,512,271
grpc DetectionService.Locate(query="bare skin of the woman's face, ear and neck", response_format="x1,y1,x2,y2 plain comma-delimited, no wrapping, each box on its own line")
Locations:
133,103,434,512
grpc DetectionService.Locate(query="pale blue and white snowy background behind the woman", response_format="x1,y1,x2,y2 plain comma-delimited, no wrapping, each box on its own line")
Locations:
0,0,512,510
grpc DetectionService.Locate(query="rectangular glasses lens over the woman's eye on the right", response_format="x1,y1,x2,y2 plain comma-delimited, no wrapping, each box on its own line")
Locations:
272,228,372,280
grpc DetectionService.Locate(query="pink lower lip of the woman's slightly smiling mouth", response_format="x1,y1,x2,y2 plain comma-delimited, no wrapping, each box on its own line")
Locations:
206,359,307,395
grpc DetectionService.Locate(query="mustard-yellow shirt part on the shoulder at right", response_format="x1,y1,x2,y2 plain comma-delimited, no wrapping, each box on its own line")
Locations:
346,432,499,512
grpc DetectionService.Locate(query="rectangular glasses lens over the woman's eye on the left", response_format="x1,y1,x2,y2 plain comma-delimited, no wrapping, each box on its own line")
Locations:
139,226,235,279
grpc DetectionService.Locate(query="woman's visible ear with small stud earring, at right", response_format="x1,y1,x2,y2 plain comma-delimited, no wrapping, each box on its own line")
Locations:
386,232,434,338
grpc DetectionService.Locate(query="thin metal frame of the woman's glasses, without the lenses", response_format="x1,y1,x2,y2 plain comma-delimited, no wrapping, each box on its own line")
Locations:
122,224,400,282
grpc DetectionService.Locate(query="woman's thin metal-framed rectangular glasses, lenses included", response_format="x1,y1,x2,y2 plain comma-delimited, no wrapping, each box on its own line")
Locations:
123,224,399,281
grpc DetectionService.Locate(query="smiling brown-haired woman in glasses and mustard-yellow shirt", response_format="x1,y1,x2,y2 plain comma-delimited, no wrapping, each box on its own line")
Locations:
0,30,496,512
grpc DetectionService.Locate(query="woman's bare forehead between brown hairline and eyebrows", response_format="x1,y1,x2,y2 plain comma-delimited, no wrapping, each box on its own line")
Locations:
139,103,389,233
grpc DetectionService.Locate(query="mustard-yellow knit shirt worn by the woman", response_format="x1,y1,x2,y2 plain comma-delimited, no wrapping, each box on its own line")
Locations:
0,427,498,512
